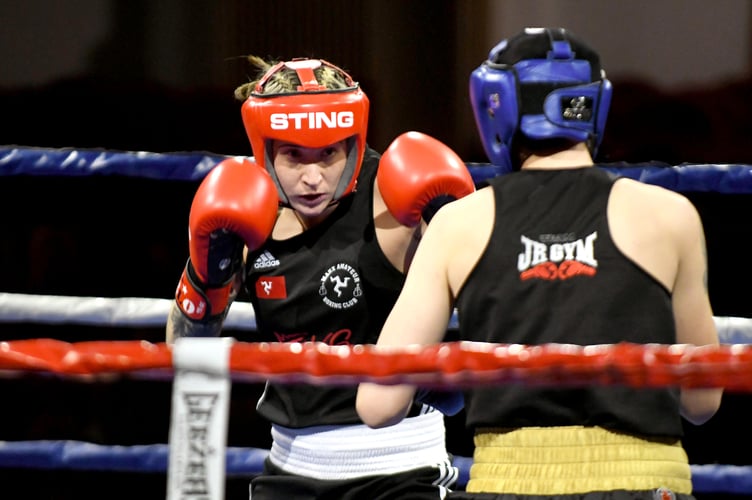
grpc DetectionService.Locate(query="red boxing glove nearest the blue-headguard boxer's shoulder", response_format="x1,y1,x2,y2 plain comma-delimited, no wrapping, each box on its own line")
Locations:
376,132,475,227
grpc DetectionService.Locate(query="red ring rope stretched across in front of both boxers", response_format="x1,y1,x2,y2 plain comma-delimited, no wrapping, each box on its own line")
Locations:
0,339,752,392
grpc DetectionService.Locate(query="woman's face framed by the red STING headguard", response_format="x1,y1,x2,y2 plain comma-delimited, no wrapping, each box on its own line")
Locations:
273,141,347,218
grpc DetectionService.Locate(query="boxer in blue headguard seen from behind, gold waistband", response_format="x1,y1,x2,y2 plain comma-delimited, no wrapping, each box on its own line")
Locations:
356,28,722,500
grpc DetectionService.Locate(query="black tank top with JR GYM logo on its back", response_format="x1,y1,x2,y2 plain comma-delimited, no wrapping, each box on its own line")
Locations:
456,167,682,436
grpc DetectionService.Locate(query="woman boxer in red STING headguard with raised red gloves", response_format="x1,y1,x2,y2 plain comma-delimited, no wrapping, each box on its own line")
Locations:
167,57,474,500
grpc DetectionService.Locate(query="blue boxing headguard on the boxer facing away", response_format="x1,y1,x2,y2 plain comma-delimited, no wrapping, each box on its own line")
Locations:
470,28,611,171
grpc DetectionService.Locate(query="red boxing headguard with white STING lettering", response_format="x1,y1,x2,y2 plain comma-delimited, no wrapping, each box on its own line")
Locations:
241,59,368,205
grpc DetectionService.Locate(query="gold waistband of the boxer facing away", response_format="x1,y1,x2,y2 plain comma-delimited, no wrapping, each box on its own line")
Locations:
466,426,692,495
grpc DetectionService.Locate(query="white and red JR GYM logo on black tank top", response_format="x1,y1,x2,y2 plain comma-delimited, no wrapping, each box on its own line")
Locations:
517,231,598,281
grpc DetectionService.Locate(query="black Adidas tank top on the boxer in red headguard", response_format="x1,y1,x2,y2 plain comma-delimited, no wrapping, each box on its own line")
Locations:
239,149,404,428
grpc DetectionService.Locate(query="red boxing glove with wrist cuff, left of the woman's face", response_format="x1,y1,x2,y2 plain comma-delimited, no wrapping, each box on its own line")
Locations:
175,158,279,321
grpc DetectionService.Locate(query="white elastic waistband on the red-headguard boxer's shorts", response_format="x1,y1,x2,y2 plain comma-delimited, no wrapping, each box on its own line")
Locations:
269,411,451,480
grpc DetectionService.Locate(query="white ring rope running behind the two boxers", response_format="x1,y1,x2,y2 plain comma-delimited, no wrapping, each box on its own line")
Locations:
0,293,752,344
